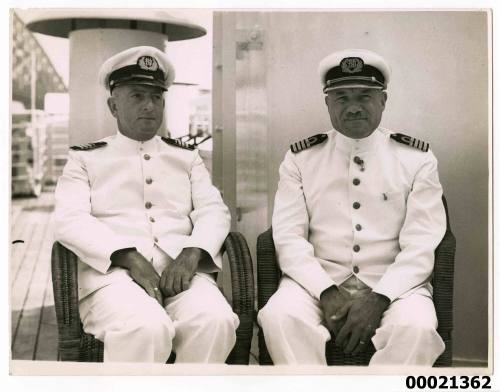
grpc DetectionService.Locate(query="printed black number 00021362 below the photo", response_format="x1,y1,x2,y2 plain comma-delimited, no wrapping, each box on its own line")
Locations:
406,376,491,389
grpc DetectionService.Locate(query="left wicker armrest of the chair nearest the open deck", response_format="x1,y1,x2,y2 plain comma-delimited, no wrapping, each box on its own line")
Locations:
51,242,82,361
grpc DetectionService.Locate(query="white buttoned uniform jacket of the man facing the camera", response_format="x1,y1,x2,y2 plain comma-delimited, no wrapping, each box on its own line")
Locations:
272,128,446,301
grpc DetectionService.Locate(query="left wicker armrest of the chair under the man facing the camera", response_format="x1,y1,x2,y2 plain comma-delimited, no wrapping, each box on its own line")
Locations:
257,227,281,310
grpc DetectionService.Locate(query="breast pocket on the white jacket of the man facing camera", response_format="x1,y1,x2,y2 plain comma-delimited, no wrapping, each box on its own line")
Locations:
366,190,407,239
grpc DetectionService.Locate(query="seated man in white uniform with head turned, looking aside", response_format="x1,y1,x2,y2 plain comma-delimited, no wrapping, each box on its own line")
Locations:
54,46,239,363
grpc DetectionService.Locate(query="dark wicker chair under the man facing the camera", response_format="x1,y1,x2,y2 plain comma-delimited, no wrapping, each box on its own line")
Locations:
257,197,456,367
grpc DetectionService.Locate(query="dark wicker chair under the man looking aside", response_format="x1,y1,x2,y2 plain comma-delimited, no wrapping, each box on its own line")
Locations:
52,232,254,365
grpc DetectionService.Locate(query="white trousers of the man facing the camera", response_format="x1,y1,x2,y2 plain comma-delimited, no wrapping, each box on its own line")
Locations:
258,276,445,366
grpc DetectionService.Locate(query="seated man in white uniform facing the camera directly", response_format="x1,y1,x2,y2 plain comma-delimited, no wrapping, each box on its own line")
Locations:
258,49,446,366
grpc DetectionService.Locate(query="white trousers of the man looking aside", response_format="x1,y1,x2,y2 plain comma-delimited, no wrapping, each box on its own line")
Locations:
79,247,239,363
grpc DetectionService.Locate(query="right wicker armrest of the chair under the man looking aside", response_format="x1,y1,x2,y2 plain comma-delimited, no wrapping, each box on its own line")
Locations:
224,232,255,365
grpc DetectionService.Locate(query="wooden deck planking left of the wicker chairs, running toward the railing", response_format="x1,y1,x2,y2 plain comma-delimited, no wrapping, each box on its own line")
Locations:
11,194,56,359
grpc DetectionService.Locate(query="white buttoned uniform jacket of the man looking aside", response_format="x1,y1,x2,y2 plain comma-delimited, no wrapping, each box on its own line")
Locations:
53,132,230,299
